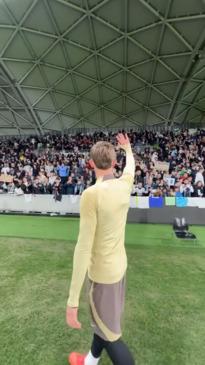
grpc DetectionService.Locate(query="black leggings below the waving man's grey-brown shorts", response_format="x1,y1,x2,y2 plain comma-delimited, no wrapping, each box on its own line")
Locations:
91,334,135,365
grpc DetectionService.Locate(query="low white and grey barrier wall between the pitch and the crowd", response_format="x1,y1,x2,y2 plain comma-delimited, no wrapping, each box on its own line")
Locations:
0,194,205,225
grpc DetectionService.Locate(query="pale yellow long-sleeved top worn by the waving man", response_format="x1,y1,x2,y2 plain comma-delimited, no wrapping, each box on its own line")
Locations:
67,145,135,307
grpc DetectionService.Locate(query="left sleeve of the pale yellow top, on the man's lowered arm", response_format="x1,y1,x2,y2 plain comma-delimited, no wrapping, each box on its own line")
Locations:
67,189,97,307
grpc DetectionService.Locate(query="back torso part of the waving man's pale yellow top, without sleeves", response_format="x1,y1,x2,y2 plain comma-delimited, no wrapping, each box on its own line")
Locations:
88,175,132,283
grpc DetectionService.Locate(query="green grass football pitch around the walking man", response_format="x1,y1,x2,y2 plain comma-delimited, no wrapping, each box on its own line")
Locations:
0,215,205,365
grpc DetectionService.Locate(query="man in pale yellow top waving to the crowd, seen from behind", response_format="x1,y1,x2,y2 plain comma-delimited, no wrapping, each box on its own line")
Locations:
66,133,135,365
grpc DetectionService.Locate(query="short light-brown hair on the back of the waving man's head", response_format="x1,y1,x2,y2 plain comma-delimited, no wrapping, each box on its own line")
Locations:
90,141,116,170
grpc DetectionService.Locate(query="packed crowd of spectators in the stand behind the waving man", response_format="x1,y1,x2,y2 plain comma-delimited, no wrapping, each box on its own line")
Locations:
0,130,205,197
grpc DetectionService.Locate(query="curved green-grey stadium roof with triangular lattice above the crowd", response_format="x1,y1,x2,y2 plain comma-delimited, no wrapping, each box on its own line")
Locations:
0,0,205,134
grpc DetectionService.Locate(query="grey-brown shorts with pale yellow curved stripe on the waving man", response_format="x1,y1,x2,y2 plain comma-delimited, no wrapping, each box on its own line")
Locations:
89,277,125,342
